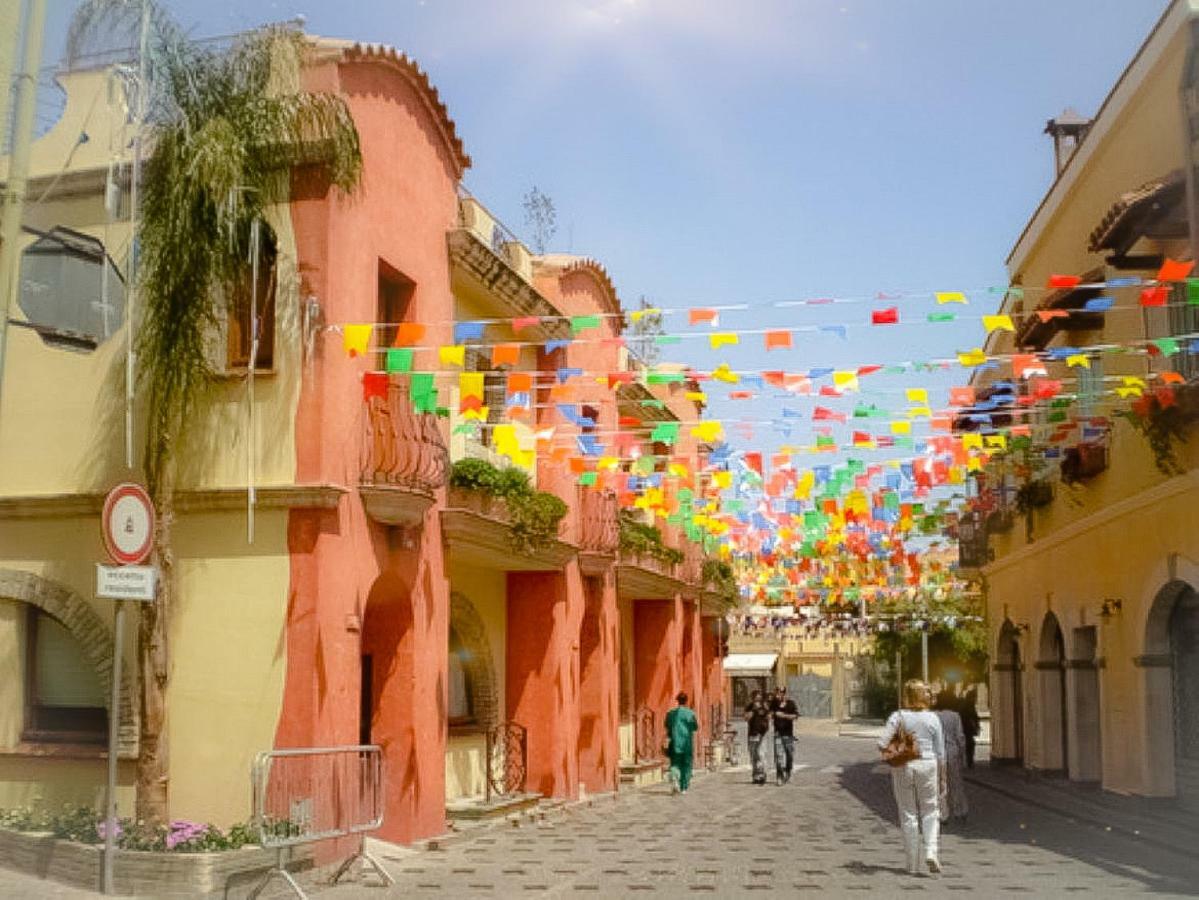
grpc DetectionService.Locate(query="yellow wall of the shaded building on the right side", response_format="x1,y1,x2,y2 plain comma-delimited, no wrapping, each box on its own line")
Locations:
981,2,1199,793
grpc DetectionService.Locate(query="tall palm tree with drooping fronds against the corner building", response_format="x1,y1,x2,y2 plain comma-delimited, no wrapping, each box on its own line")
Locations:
67,0,362,821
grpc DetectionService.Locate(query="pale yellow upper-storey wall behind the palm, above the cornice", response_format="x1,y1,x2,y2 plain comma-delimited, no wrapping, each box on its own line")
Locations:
0,72,302,496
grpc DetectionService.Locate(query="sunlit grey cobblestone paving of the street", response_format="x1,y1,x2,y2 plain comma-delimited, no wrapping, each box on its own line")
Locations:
320,735,1199,900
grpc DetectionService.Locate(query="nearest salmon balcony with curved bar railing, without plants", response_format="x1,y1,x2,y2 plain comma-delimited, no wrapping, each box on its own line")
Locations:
359,375,450,527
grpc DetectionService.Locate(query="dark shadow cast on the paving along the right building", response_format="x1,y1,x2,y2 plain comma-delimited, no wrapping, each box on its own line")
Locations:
839,761,1195,894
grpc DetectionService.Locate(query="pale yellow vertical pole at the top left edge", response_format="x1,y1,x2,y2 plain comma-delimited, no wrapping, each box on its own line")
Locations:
0,0,46,436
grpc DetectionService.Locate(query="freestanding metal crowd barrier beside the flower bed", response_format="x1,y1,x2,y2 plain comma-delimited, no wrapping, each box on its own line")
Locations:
249,745,394,900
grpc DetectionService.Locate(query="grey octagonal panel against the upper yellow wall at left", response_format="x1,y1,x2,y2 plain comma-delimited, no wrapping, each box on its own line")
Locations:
17,228,125,350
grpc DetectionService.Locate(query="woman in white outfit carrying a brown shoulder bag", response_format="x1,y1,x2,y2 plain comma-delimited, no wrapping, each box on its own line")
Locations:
879,681,945,875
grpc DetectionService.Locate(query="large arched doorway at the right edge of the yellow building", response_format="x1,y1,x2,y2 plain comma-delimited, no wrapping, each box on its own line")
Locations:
1135,580,1199,808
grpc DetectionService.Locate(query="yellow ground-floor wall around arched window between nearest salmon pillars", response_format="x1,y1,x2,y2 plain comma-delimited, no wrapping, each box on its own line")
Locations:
446,563,508,802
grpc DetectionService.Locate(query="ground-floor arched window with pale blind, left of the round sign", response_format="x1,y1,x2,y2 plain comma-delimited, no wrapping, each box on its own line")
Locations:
22,606,108,744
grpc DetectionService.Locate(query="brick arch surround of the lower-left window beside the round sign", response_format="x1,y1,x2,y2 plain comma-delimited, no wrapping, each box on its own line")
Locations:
0,569,138,759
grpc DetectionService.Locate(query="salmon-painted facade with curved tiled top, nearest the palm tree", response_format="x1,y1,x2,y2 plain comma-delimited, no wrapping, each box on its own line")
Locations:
276,50,458,841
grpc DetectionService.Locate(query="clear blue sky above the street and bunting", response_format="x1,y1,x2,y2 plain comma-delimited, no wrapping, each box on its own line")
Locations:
35,0,1167,460
